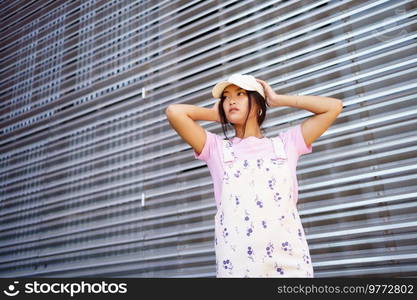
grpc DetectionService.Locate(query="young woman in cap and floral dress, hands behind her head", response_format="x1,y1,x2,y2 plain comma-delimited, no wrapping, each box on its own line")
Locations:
166,74,343,277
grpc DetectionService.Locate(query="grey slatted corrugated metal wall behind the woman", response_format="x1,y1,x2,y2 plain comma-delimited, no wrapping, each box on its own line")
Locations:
0,0,417,277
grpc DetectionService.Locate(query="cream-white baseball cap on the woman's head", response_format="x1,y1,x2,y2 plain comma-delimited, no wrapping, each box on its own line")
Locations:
211,74,265,99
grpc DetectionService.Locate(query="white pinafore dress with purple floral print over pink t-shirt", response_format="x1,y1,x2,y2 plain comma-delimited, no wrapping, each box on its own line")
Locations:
214,136,313,277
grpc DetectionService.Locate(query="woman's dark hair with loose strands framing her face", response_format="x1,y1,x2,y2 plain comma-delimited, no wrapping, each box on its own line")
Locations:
219,90,267,140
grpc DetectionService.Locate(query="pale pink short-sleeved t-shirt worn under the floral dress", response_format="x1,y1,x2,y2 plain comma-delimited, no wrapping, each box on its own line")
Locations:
193,123,313,208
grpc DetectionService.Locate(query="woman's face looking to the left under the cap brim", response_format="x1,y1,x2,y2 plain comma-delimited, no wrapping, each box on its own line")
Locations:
223,84,256,125
